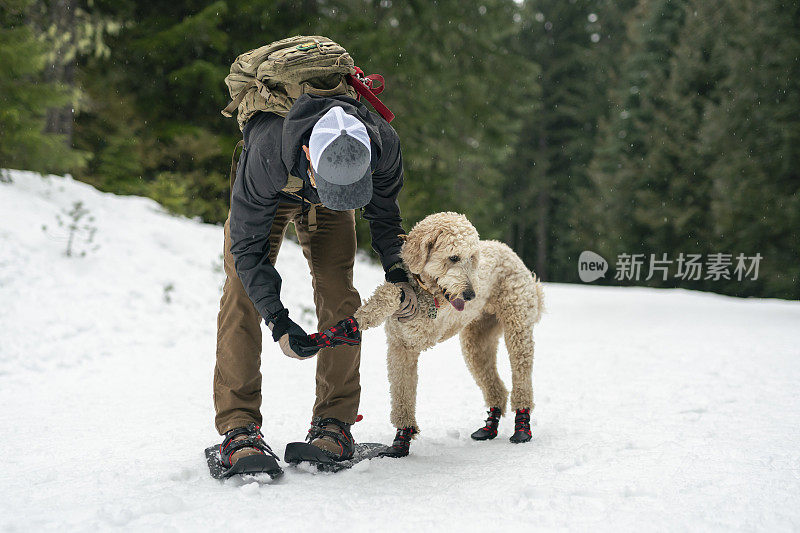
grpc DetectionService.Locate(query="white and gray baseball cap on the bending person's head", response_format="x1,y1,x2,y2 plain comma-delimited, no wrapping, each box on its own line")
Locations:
308,106,372,211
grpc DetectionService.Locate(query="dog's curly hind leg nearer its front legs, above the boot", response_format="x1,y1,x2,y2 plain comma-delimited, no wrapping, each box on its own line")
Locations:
461,314,508,413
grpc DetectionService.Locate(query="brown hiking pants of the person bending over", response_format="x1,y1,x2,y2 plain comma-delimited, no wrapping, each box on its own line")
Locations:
214,204,361,435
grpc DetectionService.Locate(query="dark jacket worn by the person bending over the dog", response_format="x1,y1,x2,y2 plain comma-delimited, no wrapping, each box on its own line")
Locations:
230,95,404,321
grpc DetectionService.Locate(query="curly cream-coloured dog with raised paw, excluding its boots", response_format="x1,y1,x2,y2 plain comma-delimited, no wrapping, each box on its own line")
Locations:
354,212,544,431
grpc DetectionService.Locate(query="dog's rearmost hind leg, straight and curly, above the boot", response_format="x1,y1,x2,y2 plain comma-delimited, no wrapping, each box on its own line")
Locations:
503,313,533,411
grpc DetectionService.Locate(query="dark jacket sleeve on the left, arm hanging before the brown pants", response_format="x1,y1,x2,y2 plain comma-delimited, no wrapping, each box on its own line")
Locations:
230,141,283,322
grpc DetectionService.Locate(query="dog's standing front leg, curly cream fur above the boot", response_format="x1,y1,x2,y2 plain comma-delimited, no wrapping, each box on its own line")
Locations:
387,336,419,433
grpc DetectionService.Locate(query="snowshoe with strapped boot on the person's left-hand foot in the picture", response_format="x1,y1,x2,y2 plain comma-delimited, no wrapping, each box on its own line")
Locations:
206,423,283,479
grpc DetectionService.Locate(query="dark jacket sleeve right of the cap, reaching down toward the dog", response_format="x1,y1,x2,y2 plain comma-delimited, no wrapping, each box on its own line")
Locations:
364,125,405,270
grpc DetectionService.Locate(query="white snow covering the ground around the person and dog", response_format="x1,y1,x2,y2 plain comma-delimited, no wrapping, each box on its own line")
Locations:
0,172,800,531
